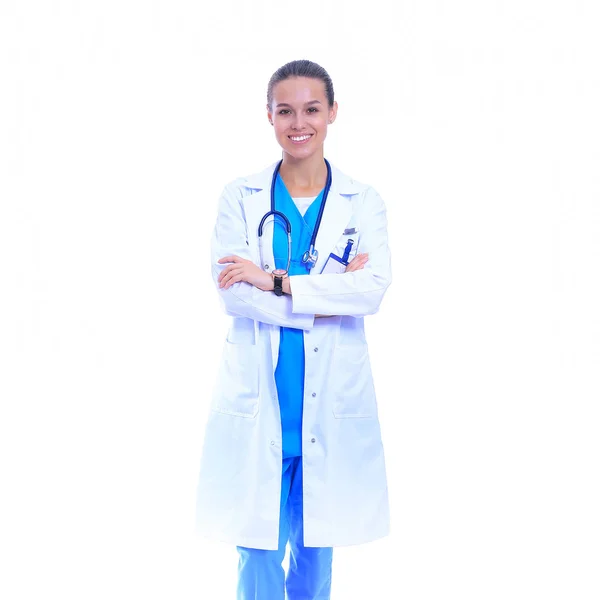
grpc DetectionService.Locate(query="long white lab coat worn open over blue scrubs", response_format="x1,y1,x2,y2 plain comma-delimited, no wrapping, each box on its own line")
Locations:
196,158,391,550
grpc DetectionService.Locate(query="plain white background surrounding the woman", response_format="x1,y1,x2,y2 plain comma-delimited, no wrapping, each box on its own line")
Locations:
0,0,600,600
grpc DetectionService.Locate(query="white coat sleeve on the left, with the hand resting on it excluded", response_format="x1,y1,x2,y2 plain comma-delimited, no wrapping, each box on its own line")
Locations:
211,180,315,329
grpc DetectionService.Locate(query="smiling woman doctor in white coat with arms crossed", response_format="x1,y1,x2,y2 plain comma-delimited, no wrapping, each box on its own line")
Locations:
196,60,391,600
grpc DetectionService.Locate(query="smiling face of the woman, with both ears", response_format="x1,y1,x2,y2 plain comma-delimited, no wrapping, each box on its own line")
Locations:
267,77,337,159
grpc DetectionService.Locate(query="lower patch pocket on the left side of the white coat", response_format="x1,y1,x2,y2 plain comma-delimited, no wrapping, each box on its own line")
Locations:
212,340,259,418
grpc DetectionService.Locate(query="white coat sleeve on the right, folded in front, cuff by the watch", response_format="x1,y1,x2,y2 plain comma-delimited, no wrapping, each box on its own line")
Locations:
290,187,392,317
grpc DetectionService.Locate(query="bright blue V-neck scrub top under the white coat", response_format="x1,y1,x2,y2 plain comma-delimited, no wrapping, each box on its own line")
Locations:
273,174,324,458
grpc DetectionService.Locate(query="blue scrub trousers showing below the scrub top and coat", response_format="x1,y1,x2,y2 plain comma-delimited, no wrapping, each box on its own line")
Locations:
237,456,333,600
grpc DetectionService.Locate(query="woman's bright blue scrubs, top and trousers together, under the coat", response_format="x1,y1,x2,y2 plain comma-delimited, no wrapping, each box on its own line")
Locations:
237,175,333,600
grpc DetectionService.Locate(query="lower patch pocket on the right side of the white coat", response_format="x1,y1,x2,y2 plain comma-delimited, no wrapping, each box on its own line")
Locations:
331,344,376,419
